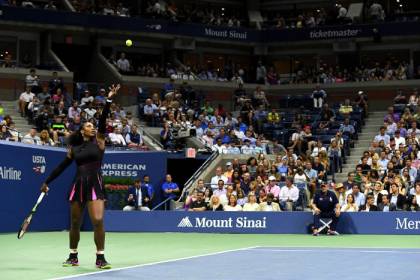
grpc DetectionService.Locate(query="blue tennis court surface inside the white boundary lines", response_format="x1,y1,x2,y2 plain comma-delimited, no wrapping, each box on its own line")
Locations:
60,247,420,280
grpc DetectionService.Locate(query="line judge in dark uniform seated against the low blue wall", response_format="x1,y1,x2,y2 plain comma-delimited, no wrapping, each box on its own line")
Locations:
312,184,340,236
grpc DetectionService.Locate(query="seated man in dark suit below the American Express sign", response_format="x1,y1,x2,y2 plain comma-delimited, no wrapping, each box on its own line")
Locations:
123,179,150,211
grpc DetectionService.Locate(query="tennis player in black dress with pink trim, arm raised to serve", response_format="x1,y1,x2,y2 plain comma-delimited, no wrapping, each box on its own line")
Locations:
41,85,120,269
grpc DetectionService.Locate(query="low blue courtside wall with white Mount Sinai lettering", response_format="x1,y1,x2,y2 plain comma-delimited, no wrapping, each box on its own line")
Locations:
105,211,420,234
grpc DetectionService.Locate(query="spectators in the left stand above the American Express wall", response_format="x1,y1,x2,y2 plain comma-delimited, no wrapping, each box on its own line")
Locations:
1,69,147,150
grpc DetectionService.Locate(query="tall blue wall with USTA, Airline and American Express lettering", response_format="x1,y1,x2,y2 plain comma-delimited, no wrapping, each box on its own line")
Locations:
0,142,166,232
